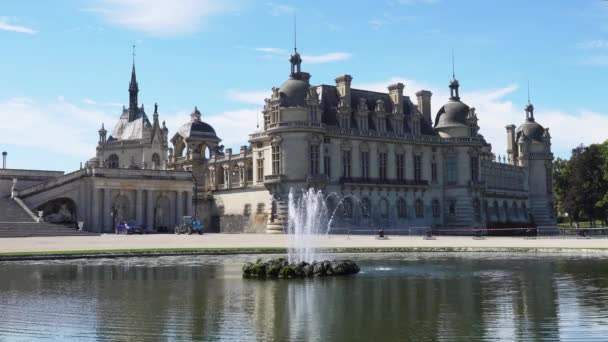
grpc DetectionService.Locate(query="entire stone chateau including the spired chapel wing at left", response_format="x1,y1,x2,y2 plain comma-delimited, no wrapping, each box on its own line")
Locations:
5,50,555,233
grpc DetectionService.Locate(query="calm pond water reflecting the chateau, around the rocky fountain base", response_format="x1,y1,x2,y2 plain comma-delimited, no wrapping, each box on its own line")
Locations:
0,253,608,341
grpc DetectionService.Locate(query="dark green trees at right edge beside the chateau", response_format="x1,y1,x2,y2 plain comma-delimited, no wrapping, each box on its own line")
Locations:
553,140,608,226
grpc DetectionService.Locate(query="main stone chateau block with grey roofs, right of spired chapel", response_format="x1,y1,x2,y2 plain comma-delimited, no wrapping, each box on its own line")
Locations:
167,51,555,233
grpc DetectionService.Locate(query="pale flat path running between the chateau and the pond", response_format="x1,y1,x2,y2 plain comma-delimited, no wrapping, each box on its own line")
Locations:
0,234,608,253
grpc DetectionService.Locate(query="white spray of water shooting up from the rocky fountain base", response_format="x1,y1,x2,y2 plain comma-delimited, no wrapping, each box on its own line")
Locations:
287,188,333,263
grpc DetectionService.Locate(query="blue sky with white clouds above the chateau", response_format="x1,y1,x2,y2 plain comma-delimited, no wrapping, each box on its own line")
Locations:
0,0,608,171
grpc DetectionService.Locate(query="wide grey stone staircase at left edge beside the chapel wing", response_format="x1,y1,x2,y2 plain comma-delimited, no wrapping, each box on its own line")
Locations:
0,198,94,238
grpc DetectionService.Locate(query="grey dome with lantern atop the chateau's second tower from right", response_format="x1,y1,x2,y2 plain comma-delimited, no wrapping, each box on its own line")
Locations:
434,78,476,138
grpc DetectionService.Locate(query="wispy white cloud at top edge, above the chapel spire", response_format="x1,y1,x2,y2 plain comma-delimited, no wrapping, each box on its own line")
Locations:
83,0,237,36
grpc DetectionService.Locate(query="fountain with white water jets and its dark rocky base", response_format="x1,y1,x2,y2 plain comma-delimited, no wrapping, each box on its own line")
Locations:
243,188,359,278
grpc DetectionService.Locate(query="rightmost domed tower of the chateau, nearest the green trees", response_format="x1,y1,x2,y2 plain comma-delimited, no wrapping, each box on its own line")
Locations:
512,101,556,226
